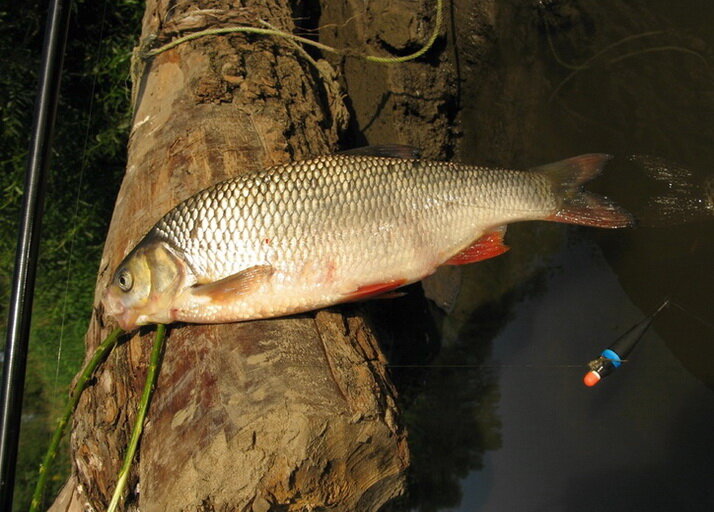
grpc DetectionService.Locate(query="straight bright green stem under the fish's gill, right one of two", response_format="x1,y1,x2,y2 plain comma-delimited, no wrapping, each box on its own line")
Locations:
107,324,166,512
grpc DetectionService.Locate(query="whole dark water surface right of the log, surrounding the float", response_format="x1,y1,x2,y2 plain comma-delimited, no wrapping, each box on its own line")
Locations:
392,0,714,512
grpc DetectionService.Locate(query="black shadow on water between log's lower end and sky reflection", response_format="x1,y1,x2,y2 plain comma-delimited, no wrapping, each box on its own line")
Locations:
367,262,545,512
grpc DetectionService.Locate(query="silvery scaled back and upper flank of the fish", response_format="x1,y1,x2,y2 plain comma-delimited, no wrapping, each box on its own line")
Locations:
156,156,544,286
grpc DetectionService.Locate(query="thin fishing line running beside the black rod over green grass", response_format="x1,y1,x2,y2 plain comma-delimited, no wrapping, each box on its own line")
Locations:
54,0,107,389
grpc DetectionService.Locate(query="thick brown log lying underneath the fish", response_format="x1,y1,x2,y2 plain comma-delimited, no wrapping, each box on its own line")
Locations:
46,0,450,512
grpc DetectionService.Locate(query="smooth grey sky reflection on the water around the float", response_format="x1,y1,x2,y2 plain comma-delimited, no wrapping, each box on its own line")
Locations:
442,234,714,512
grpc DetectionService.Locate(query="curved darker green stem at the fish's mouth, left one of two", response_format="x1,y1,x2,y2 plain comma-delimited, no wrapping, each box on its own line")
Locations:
30,329,124,512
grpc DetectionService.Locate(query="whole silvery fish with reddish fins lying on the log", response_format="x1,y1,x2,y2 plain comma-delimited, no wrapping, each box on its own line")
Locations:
102,146,632,331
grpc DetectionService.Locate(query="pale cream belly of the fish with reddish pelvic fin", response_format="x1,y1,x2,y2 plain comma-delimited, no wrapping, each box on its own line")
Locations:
177,210,496,322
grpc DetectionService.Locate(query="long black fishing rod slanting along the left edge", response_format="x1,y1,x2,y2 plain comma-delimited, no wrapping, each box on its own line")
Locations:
0,0,71,511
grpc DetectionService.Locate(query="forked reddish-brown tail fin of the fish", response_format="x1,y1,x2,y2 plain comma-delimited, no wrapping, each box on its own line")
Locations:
534,153,633,228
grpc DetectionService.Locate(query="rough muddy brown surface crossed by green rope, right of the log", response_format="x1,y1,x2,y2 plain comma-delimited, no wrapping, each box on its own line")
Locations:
320,0,456,159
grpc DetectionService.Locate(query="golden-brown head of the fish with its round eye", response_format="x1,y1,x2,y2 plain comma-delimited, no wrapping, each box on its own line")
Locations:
102,239,188,331
